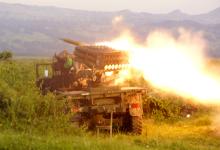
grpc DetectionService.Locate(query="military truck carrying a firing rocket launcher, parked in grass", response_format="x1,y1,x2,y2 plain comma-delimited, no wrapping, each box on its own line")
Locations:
36,39,146,134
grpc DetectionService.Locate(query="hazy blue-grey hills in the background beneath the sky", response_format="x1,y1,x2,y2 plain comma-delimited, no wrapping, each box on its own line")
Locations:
0,3,220,57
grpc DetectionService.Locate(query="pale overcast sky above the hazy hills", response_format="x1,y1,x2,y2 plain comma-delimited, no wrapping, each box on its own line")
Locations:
0,0,220,14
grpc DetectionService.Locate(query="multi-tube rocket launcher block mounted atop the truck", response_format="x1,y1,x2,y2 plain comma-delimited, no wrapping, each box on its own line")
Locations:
63,39,129,71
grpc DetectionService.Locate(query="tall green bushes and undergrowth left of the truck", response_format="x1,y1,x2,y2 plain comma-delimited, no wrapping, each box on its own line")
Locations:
0,60,80,134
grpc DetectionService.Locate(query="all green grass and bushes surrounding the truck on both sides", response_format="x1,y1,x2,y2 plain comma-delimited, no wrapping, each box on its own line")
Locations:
0,59,220,150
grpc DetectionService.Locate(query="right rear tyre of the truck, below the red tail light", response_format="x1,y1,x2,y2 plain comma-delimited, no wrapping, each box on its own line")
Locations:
131,116,143,135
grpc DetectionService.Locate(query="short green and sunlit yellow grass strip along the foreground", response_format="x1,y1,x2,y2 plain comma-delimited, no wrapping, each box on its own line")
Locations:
0,119,220,150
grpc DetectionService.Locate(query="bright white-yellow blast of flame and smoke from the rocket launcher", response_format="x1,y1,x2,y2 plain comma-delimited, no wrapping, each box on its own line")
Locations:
97,29,220,103
